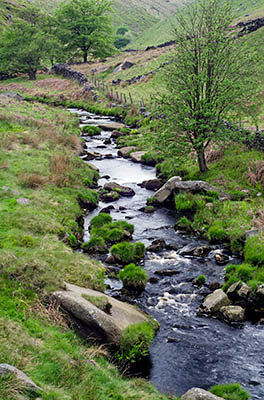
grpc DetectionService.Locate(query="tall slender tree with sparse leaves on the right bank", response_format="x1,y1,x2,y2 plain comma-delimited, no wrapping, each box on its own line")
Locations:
157,0,253,172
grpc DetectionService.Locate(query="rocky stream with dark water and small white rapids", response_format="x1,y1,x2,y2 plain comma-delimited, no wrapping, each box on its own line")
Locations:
69,109,264,400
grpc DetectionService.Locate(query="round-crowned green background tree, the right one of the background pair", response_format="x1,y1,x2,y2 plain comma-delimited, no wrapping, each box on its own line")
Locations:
55,0,114,62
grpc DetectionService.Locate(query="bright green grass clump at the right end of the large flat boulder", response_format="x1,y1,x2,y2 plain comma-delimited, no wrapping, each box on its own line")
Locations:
117,322,154,363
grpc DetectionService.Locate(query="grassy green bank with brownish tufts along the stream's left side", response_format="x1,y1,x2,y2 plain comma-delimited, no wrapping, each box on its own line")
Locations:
0,91,182,400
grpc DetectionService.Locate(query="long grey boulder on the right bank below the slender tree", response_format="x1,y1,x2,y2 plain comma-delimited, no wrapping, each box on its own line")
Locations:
151,176,229,203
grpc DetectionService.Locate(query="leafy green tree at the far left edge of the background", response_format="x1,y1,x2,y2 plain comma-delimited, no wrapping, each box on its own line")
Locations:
0,7,58,79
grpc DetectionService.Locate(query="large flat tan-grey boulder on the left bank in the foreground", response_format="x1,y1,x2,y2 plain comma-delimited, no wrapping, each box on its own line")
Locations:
53,283,148,346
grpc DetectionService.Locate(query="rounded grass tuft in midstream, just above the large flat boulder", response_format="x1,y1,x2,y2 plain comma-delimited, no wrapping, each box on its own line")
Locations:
118,263,147,290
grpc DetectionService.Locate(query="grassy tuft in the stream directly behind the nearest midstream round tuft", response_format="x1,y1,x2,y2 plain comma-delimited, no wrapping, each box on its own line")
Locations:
110,242,145,265
